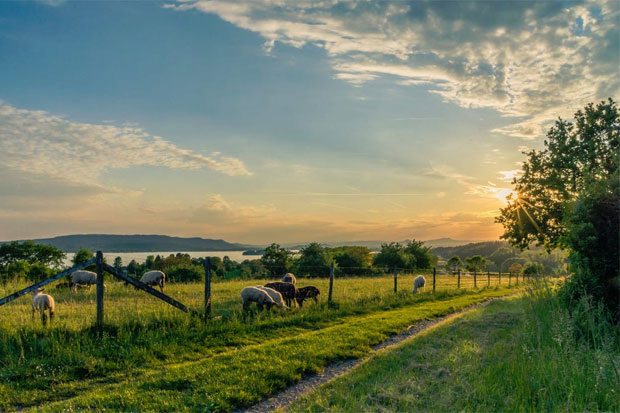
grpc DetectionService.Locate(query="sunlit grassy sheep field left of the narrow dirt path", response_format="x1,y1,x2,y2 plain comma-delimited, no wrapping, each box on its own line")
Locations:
0,275,517,410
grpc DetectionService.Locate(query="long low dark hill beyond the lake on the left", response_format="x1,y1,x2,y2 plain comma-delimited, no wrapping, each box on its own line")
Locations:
3,234,253,252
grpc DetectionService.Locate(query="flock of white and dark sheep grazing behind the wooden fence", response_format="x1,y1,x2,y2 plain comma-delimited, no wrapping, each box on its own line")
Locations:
31,270,426,325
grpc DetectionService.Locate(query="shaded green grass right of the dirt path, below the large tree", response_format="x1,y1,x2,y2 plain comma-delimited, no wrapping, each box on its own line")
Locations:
290,289,620,412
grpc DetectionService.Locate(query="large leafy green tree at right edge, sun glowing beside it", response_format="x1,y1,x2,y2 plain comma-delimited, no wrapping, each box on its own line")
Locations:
496,99,620,317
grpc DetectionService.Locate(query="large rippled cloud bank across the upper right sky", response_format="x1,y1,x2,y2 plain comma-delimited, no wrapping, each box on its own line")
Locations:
164,0,620,139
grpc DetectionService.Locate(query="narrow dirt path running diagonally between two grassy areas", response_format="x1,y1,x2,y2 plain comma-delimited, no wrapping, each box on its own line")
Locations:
236,292,521,413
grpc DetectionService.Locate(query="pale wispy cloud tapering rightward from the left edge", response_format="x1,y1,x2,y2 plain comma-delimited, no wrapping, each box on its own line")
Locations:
0,101,250,194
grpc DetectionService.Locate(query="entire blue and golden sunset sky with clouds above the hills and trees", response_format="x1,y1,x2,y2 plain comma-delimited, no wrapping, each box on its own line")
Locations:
0,0,620,244
